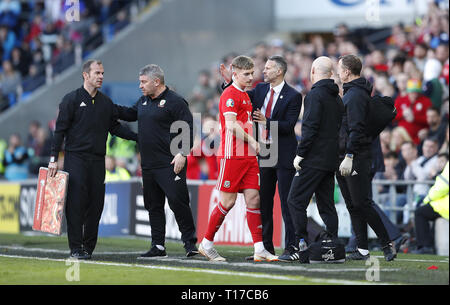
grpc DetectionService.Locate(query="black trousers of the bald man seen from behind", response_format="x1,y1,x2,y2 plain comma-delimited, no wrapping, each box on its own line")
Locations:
288,167,338,246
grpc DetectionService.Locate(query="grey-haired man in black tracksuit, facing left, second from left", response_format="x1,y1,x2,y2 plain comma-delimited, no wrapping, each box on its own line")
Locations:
117,65,198,258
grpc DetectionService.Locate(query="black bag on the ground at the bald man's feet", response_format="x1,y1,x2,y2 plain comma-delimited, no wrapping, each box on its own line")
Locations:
308,231,345,264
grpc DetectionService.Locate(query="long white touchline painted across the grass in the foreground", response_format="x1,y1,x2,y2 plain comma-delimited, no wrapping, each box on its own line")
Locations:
0,254,386,285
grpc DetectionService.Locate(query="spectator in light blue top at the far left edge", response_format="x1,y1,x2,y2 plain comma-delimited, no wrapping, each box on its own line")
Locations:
3,134,33,181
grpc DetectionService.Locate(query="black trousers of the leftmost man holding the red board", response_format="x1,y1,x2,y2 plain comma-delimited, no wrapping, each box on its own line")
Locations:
64,152,105,254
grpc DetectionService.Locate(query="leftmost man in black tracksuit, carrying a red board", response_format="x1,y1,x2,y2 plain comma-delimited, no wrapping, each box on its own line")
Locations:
48,60,137,259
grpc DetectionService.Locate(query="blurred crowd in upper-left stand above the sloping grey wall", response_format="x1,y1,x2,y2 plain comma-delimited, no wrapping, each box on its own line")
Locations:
0,0,151,112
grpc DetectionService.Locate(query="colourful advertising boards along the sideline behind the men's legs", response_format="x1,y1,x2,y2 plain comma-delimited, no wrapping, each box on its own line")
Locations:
0,177,284,247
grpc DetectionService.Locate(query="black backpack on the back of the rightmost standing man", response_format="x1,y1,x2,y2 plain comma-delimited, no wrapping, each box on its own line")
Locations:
366,95,397,138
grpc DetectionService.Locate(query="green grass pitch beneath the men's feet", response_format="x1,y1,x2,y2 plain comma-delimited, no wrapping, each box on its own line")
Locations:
0,234,449,285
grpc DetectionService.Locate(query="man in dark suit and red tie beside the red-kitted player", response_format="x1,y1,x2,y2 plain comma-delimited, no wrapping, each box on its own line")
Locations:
221,55,302,254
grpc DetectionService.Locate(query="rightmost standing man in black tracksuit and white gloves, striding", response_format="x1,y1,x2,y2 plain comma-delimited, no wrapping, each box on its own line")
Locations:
336,55,396,261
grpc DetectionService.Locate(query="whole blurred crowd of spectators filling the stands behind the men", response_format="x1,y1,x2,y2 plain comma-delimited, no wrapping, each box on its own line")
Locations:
0,0,449,252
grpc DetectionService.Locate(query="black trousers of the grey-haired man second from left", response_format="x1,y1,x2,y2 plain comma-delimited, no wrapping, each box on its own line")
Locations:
142,166,197,246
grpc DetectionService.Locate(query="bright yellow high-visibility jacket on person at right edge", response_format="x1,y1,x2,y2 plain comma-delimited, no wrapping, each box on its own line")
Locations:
423,162,449,220
